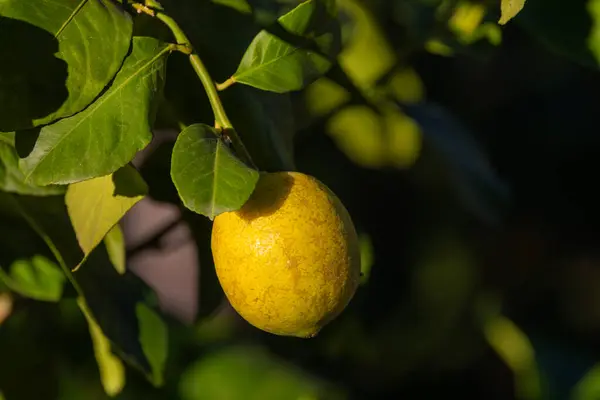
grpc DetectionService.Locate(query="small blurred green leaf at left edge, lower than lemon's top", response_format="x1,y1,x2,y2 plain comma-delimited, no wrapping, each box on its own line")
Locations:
0,255,66,302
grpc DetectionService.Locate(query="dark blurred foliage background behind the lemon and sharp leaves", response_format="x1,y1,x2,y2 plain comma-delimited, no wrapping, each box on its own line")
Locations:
0,0,600,400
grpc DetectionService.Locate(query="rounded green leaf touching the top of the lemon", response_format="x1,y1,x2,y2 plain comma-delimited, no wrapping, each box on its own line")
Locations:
171,124,259,219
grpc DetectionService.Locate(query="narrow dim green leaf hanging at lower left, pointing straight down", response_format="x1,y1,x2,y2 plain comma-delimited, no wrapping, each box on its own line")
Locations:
136,303,169,386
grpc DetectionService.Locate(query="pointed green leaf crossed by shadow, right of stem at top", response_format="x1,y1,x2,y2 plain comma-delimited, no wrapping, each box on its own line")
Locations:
230,0,339,93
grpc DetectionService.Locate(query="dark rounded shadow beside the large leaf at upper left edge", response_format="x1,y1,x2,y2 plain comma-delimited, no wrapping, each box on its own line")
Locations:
0,17,69,132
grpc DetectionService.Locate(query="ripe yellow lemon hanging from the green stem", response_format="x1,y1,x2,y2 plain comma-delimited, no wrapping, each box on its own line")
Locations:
211,172,360,338
